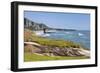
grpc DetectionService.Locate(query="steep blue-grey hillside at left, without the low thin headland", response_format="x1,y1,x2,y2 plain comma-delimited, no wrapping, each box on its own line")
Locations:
24,18,49,30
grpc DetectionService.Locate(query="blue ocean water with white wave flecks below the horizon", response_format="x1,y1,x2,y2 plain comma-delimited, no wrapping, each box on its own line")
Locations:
45,30,90,49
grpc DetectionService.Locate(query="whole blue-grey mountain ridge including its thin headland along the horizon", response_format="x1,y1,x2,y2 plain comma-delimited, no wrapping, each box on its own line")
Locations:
24,18,75,31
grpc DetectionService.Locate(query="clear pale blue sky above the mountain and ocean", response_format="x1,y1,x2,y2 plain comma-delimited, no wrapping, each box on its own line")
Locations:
24,11,90,30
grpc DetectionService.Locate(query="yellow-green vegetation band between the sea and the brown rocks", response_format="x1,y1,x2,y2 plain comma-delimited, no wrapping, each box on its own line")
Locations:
24,30,81,48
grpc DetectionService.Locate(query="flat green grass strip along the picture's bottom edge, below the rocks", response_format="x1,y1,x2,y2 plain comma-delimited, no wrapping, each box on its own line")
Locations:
24,53,88,62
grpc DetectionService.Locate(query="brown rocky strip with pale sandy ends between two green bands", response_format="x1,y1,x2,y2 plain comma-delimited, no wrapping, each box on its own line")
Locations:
24,42,90,57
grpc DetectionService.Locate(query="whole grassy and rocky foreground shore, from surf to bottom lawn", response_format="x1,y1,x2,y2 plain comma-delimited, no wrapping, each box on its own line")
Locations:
24,30,91,61
